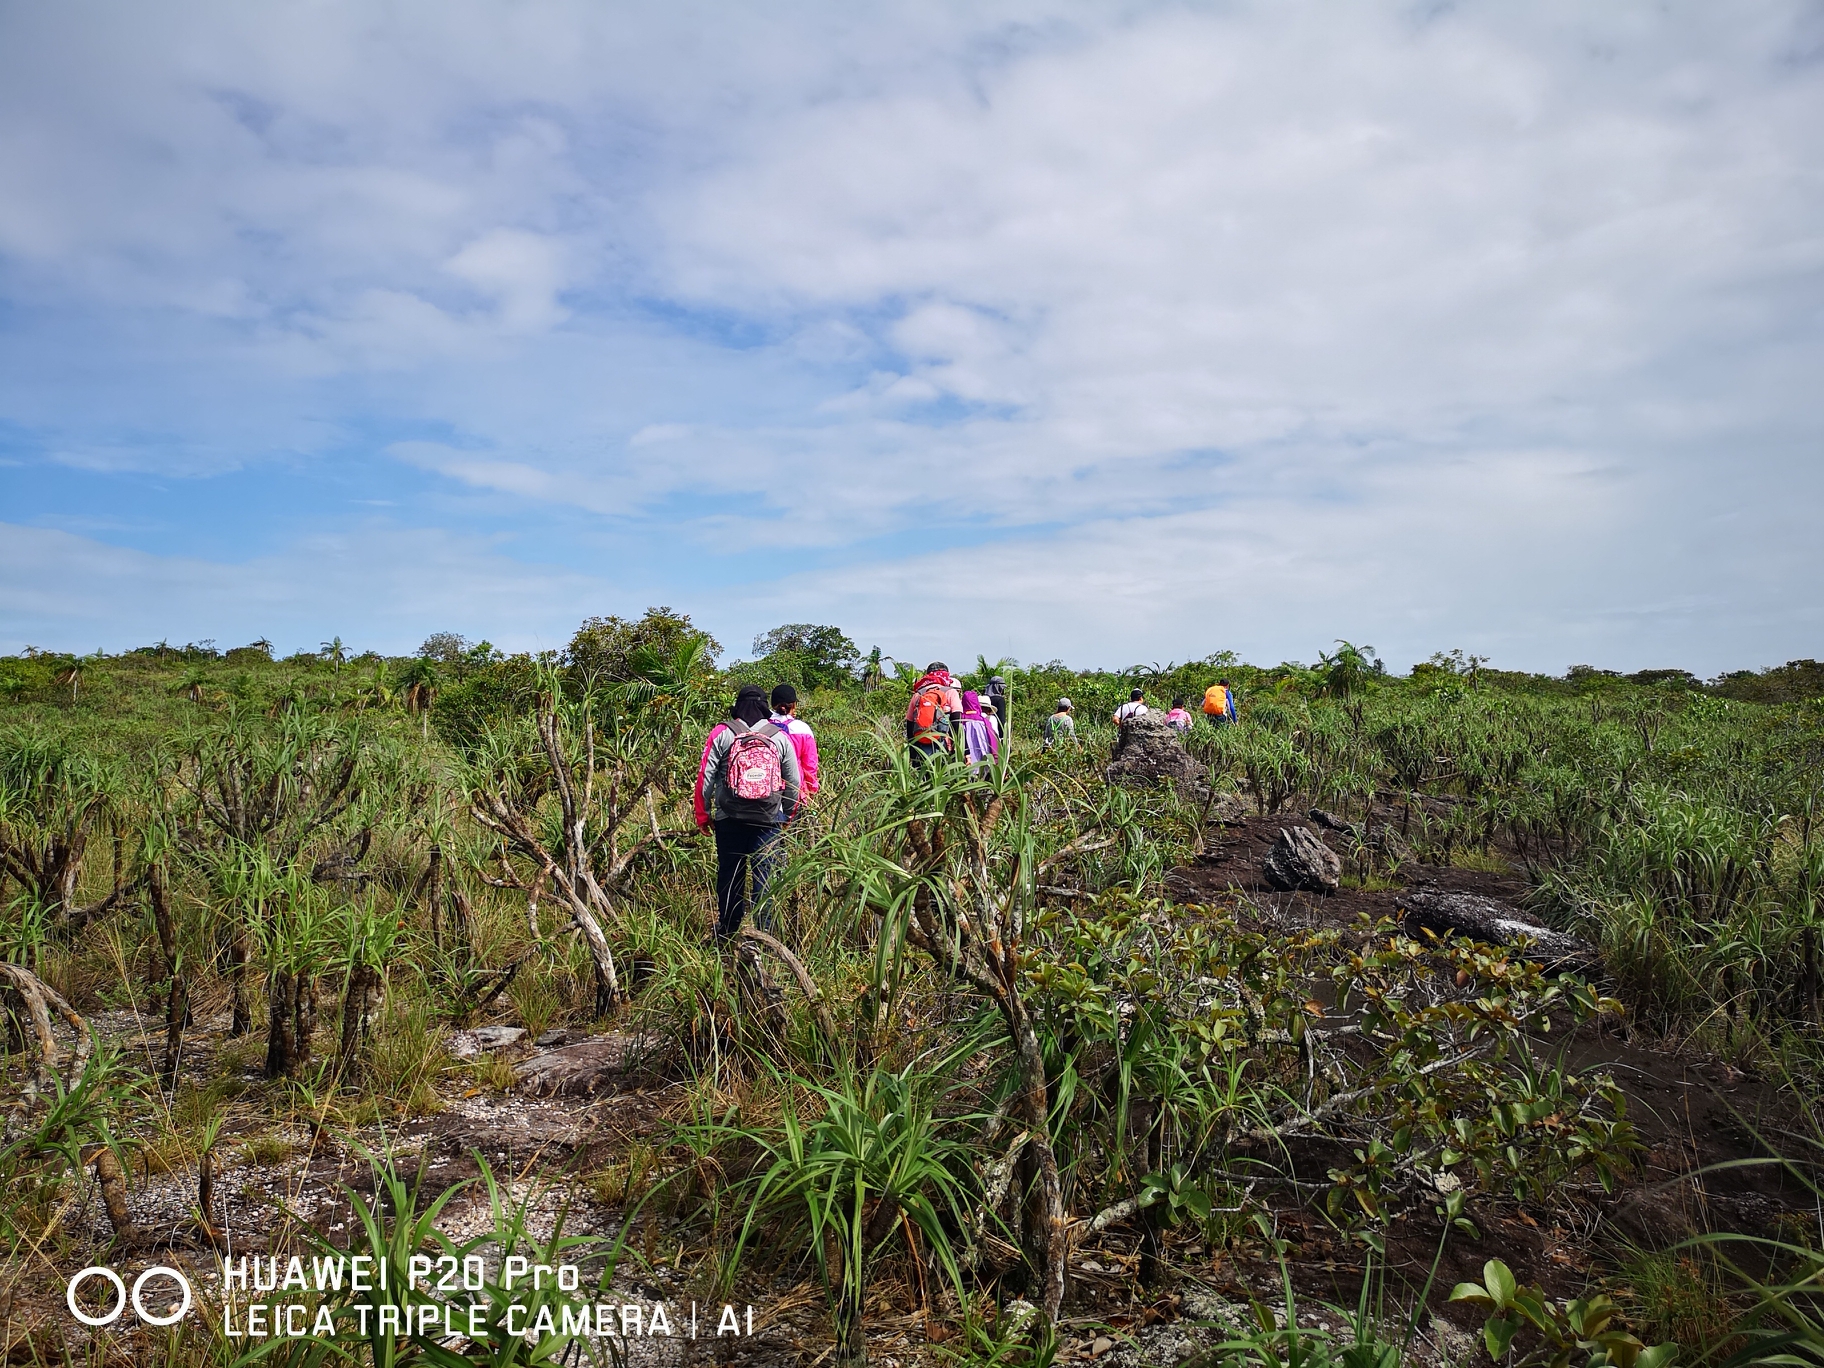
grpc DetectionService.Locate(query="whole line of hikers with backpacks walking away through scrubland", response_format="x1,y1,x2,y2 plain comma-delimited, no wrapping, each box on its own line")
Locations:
693,660,1235,943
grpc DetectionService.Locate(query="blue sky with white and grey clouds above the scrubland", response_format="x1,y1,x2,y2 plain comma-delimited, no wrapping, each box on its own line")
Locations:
0,0,1824,673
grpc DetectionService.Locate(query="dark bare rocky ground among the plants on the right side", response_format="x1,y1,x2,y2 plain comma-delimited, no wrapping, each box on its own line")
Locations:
1169,803,1815,1328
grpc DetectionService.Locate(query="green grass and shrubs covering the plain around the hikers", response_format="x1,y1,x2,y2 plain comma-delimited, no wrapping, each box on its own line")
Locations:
0,624,1824,1363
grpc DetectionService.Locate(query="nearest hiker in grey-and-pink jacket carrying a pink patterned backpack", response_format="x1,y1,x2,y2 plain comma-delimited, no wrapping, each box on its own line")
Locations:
697,684,801,945
